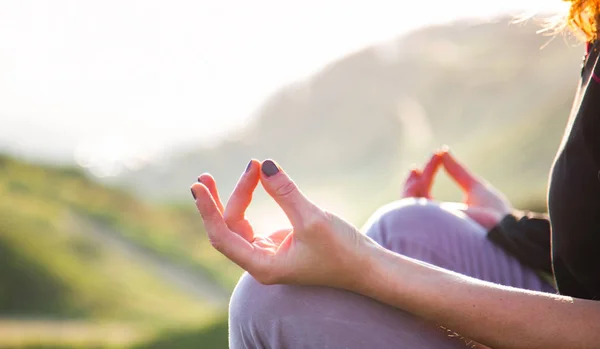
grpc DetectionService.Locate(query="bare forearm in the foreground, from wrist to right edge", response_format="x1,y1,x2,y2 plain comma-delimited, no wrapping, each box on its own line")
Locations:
354,243,600,349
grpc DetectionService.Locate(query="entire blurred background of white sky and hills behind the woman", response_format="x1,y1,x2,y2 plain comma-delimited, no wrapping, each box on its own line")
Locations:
0,0,583,349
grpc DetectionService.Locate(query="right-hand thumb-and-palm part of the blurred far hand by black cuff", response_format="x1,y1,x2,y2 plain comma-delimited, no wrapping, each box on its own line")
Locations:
441,151,513,229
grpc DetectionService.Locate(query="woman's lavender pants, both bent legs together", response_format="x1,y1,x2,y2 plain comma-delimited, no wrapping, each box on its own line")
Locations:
229,199,555,349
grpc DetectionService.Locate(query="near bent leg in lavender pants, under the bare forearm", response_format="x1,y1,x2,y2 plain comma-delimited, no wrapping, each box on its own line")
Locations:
229,274,472,349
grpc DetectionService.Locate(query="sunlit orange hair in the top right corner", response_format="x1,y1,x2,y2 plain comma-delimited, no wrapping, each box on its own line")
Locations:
559,0,600,42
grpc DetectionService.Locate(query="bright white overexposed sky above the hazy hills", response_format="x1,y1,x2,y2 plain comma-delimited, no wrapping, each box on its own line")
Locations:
0,0,565,173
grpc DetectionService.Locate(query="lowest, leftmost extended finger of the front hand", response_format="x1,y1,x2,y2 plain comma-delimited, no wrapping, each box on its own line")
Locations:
191,183,254,270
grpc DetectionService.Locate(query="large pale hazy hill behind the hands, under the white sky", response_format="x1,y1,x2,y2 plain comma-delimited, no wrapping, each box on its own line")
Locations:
119,18,583,222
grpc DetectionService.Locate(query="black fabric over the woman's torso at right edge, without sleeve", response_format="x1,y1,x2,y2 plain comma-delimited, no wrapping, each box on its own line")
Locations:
548,42,600,299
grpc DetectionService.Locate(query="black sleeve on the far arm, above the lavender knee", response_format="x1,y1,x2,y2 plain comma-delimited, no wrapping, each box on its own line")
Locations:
488,212,552,274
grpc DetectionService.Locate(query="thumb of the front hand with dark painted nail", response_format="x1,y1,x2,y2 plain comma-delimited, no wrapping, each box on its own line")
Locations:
260,160,322,228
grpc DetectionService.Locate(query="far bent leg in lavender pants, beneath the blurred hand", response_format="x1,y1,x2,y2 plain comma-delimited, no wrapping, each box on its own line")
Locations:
363,199,556,293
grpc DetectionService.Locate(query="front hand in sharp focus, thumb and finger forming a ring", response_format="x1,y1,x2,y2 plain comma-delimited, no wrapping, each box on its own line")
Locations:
191,160,380,289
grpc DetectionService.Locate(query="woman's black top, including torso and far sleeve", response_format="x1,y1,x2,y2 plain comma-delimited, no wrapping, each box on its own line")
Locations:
488,41,600,300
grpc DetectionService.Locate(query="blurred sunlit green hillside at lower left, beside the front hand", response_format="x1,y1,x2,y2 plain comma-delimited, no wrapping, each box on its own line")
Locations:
0,156,240,347
